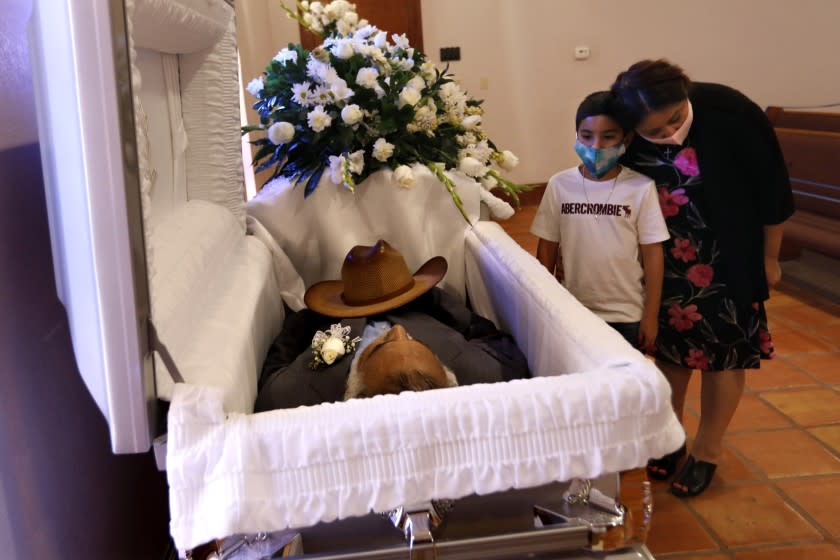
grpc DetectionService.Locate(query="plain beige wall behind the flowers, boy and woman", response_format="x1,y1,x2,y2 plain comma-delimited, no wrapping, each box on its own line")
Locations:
240,0,840,182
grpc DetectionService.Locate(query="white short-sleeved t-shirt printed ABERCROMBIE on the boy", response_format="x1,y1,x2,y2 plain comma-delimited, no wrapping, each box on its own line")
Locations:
531,167,669,323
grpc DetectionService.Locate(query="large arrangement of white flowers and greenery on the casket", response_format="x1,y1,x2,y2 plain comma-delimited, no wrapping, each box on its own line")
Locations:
242,0,529,219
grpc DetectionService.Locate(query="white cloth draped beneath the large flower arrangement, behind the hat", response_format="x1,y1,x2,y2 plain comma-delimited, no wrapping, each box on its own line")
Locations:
247,166,481,300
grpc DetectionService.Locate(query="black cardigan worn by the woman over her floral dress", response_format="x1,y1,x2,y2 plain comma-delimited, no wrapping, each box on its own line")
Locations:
622,82,793,305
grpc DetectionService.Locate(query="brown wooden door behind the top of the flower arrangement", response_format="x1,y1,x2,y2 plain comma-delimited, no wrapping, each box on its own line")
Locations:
300,0,423,51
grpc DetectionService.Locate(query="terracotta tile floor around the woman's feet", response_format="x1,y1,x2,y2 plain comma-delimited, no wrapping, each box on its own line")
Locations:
502,206,840,560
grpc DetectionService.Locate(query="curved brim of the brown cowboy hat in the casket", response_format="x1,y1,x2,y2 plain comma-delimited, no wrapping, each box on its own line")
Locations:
303,257,447,319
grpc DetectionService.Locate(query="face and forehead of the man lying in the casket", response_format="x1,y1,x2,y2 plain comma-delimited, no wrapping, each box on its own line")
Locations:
345,325,452,398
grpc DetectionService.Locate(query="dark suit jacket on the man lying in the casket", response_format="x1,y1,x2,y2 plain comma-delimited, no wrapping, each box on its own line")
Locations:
254,288,529,412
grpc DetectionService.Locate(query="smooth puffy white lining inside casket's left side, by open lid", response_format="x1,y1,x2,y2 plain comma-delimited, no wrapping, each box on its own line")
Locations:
149,200,284,413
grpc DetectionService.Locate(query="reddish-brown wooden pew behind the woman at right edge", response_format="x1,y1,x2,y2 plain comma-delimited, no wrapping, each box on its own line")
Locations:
767,107,840,260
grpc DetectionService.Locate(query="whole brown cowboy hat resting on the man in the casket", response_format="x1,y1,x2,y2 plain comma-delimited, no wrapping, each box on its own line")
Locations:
303,239,447,318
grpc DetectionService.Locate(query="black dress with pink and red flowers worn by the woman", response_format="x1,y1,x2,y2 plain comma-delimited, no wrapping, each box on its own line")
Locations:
630,143,774,371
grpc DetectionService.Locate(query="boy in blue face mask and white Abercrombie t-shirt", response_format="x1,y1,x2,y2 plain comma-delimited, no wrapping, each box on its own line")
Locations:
531,92,669,349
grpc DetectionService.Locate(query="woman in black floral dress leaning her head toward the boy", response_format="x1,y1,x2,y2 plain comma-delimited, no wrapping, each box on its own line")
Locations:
612,60,793,497
